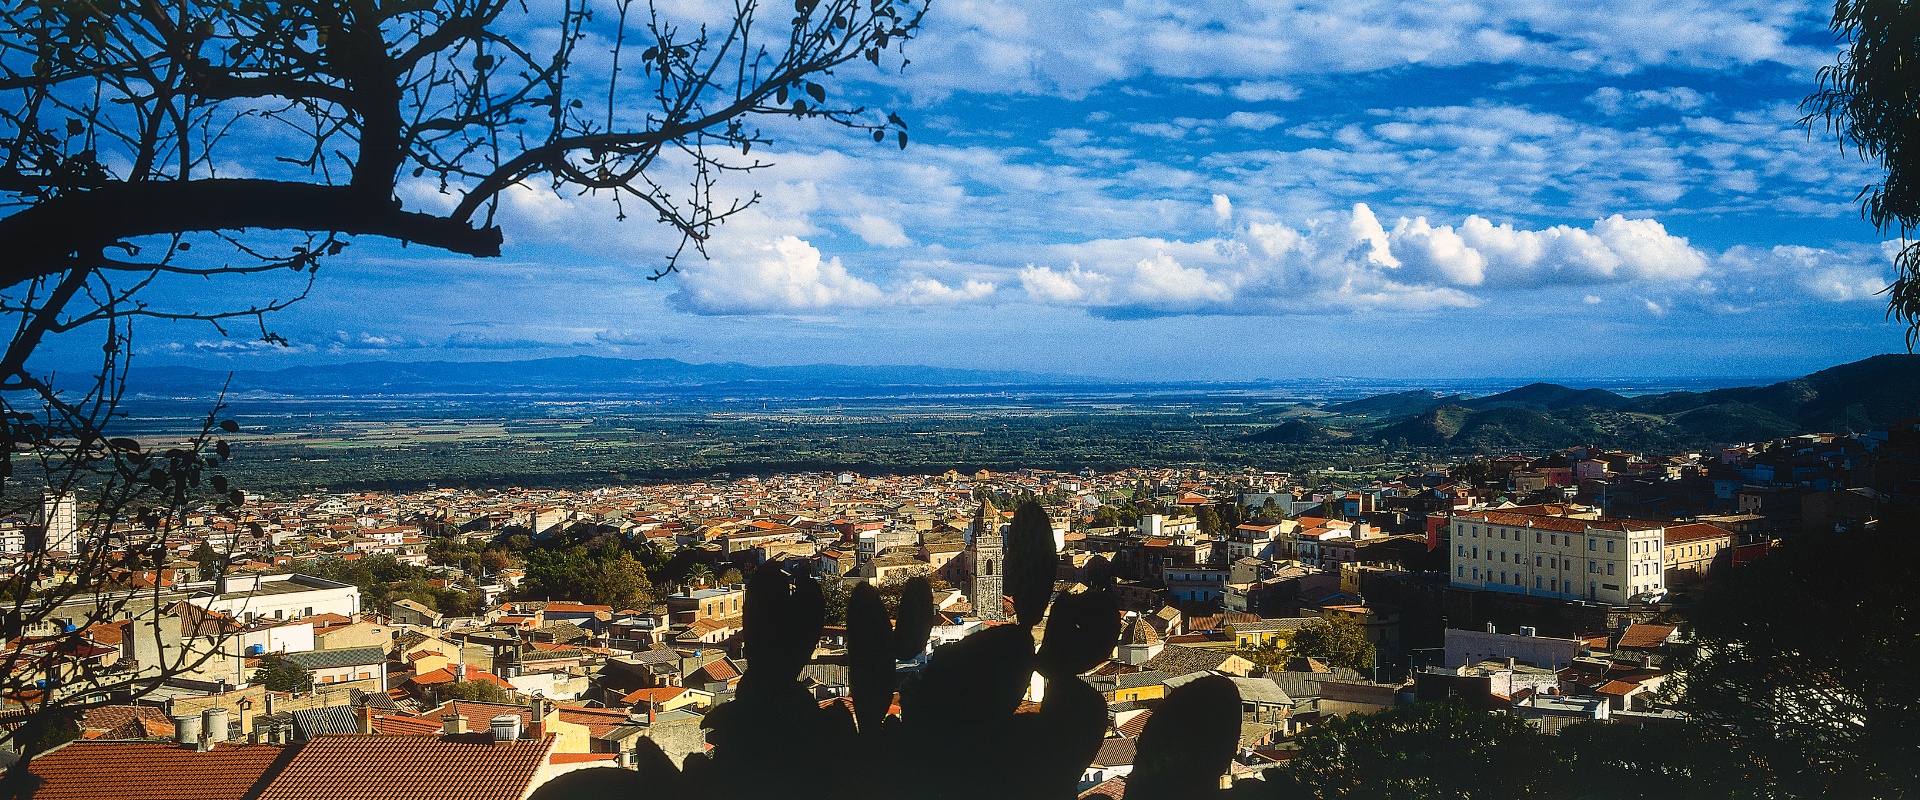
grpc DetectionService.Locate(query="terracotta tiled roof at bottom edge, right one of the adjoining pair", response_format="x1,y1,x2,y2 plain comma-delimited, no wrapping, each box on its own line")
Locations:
259,735,555,800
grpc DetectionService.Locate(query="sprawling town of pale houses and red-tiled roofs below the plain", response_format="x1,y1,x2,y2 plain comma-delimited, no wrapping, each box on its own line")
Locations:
0,420,1920,798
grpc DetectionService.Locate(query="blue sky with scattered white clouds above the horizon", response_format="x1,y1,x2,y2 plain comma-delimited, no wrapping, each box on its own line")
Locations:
82,0,1905,380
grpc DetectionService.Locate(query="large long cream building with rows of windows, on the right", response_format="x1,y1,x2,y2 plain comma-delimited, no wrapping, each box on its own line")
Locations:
1450,510,1667,604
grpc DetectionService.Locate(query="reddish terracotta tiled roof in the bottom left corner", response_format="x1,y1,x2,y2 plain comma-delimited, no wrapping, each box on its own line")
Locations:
27,741,284,800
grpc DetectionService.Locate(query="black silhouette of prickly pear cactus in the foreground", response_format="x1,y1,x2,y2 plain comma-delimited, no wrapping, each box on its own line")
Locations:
530,556,1240,800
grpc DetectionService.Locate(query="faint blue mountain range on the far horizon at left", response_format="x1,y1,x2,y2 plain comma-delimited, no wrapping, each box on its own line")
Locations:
131,355,1081,397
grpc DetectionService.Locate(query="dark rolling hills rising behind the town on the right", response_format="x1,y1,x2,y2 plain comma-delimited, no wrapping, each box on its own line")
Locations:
1248,353,1920,449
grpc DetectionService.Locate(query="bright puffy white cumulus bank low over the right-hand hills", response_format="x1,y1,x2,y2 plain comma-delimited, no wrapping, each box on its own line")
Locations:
1020,204,1711,315
